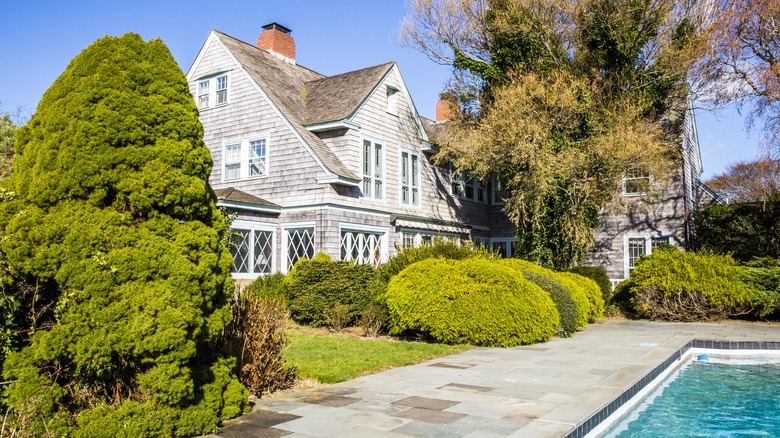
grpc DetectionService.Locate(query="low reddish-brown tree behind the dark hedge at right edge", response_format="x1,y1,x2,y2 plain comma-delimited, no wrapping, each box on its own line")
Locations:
707,158,780,202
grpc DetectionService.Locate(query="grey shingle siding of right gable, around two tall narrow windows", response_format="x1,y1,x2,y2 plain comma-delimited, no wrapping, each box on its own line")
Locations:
321,68,490,231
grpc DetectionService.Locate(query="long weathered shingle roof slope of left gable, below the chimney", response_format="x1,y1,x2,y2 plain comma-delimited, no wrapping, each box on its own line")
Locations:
213,30,360,184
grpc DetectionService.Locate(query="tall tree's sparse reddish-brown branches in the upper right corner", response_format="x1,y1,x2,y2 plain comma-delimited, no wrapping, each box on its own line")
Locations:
696,0,780,153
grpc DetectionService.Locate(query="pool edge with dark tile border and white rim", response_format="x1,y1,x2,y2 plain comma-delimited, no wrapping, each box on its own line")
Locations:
565,339,780,438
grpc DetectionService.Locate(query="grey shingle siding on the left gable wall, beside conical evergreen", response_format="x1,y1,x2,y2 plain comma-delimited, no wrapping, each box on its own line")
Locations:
189,34,325,207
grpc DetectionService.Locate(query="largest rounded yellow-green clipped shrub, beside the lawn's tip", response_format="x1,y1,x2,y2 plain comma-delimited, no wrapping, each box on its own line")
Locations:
384,259,560,347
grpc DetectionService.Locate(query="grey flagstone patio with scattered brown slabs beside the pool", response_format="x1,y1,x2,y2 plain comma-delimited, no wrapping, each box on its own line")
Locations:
209,321,780,438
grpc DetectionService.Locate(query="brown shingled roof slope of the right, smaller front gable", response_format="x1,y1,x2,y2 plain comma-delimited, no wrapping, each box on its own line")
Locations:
304,62,395,125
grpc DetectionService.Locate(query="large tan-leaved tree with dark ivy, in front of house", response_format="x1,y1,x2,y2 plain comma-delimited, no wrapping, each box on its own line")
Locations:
402,0,707,268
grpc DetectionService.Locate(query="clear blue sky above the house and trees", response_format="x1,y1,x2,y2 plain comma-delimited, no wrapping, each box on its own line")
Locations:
0,0,758,180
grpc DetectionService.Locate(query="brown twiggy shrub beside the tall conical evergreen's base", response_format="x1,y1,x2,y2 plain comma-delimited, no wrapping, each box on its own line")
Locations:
213,290,295,397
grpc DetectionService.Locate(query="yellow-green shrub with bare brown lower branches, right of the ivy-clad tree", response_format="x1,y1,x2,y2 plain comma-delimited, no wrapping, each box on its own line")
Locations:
628,246,759,321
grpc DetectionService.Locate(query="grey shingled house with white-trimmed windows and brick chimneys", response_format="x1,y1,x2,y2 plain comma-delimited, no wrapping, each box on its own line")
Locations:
187,23,716,279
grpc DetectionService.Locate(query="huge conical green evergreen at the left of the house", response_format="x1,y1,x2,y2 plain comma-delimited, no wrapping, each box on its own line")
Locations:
0,34,247,437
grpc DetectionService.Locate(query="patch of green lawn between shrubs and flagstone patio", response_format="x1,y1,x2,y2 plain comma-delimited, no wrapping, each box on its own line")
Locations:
284,332,474,383
